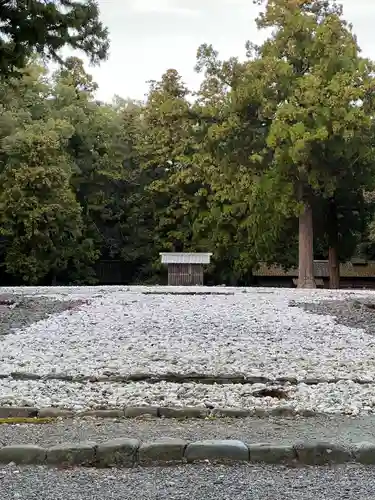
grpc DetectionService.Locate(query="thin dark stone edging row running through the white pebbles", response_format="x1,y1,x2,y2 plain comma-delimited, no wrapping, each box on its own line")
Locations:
0,372,375,386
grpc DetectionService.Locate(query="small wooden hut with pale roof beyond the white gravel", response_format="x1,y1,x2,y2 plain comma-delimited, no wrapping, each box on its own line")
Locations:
160,253,212,286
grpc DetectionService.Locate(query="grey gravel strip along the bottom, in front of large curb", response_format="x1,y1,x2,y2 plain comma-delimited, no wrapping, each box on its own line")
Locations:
0,465,375,500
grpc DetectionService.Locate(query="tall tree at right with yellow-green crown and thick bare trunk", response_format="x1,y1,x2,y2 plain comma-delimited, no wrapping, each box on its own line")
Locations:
256,0,374,287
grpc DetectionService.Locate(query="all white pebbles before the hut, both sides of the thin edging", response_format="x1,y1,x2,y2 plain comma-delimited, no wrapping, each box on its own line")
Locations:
0,287,375,411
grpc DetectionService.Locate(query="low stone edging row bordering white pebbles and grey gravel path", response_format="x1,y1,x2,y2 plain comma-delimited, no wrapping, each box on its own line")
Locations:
0,406,322,420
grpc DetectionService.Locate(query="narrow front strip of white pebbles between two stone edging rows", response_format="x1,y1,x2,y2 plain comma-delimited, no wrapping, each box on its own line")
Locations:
0,379,375,415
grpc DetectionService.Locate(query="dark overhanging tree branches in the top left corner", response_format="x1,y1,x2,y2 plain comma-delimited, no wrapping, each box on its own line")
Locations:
0,0,109,76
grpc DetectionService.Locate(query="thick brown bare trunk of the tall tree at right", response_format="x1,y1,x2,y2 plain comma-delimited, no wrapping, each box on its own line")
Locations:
298,187,316,288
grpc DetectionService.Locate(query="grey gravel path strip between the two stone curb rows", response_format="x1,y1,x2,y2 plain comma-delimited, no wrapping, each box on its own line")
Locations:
0,416,375,446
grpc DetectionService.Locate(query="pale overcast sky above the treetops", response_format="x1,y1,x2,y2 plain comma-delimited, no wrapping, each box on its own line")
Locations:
80,0,375,100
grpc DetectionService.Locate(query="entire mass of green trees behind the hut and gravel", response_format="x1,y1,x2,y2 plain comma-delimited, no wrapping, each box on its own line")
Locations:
0,0,375,287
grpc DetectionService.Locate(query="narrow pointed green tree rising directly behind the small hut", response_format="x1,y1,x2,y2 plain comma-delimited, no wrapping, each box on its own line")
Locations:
138,70,202,262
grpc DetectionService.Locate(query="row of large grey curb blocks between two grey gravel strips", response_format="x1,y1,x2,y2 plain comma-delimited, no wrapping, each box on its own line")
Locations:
0,438,375,468
